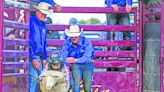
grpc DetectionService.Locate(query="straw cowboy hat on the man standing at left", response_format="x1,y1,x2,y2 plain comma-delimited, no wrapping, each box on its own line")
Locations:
33,2,53,15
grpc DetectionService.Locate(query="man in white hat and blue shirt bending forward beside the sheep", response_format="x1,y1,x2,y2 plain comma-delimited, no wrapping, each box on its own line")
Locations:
62,25,94,92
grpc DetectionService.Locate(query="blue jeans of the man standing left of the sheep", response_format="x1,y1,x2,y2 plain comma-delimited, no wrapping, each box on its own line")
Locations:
29,56,42,92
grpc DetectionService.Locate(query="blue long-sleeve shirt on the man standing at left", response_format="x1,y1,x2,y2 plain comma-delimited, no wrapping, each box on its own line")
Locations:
29,15,47,60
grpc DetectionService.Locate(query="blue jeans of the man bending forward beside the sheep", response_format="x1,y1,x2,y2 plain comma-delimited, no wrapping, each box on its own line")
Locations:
71,63,94,92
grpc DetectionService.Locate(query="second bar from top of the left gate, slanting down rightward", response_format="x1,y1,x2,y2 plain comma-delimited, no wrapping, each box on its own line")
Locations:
4,20,29,30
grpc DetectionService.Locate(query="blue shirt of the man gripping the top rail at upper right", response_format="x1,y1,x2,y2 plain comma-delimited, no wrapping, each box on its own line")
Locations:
105,0,133,7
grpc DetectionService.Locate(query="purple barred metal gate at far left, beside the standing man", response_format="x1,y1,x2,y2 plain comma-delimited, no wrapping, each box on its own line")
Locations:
0,0,30,92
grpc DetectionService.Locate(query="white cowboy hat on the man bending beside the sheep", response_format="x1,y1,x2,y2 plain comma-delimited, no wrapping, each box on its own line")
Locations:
65,25,83,37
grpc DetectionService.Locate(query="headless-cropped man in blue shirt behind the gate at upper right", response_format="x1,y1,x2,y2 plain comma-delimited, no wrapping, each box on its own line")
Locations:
105,0,132,50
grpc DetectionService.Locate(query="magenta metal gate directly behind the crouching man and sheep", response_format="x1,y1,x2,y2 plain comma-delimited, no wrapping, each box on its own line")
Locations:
47,7,141,92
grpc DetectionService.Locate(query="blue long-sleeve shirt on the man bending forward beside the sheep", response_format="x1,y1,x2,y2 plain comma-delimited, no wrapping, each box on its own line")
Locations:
61,37,94,63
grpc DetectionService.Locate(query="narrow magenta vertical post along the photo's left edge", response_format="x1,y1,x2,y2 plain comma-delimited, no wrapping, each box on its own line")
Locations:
0,0,4,92
